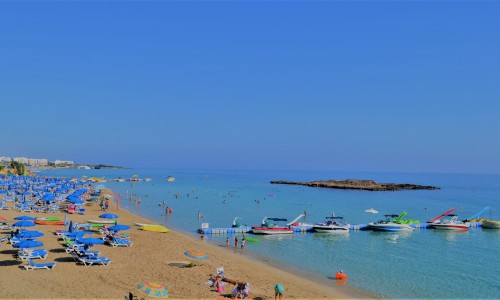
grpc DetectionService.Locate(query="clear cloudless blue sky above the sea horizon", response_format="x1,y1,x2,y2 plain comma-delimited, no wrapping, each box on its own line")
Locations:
0,1,500,173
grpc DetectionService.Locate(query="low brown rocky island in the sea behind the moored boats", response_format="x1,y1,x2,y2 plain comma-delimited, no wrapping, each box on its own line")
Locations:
271,179,440,191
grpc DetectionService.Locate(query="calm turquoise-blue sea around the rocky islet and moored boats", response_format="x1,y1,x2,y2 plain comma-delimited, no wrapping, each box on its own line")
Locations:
39,169,500,299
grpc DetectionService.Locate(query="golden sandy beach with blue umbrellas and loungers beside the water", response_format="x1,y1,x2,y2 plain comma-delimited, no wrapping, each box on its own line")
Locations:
0,191,373,299
